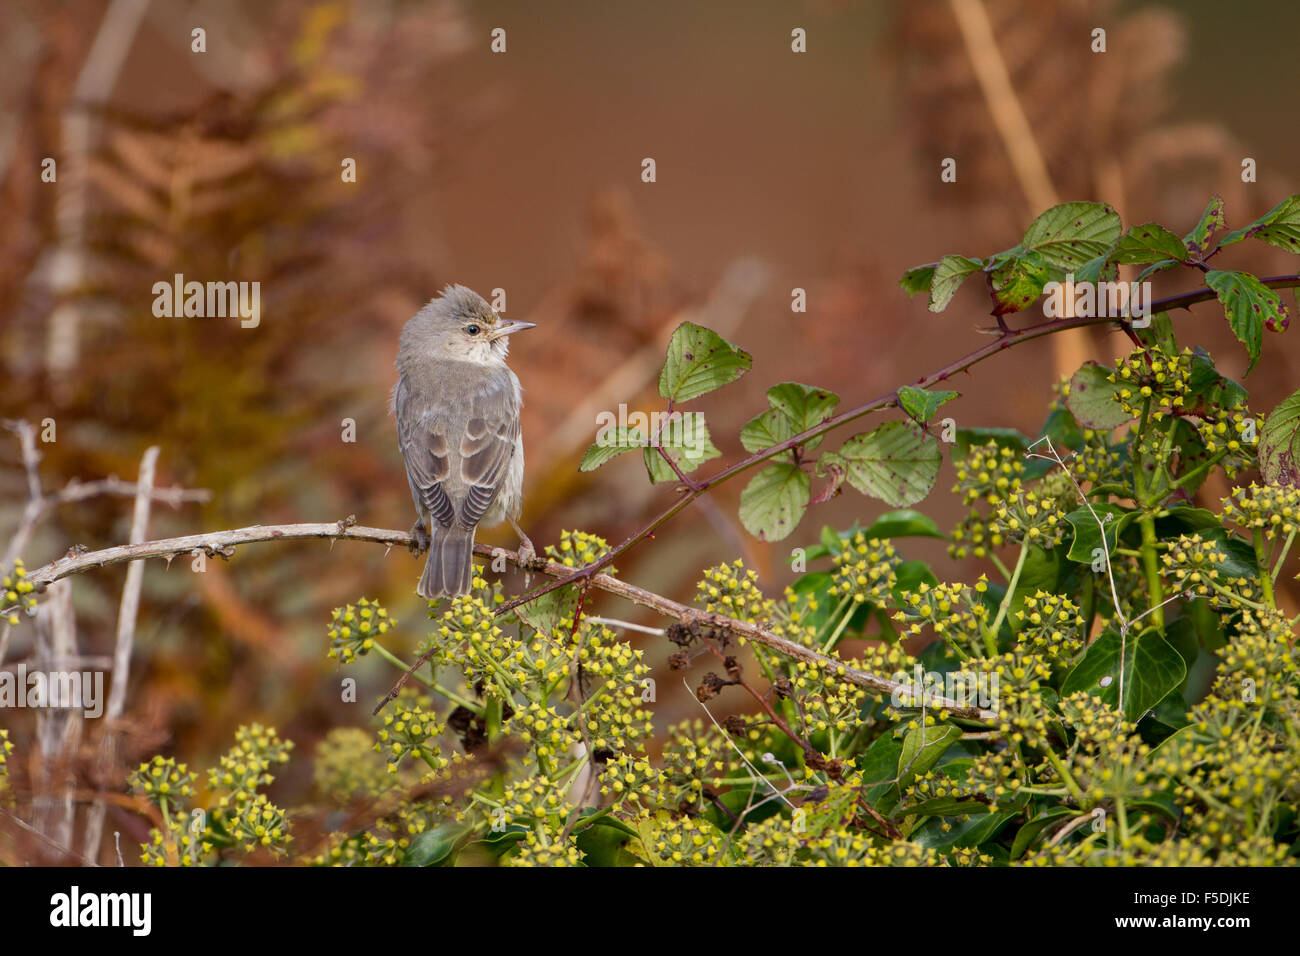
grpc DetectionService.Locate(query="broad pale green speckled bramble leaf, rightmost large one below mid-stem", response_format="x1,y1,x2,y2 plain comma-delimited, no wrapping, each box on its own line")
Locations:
823,421,943,507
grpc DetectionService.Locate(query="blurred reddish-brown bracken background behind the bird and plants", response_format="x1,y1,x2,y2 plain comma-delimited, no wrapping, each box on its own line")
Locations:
0,0,1300,863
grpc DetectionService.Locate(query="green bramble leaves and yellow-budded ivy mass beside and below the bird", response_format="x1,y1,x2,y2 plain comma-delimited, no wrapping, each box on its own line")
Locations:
129,200,1300,866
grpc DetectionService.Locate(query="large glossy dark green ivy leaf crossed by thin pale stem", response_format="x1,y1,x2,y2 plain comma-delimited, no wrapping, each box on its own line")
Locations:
1061,628,1187,723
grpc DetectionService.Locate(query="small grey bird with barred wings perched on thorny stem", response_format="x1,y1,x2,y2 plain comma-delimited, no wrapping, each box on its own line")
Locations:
391,285,536,598
